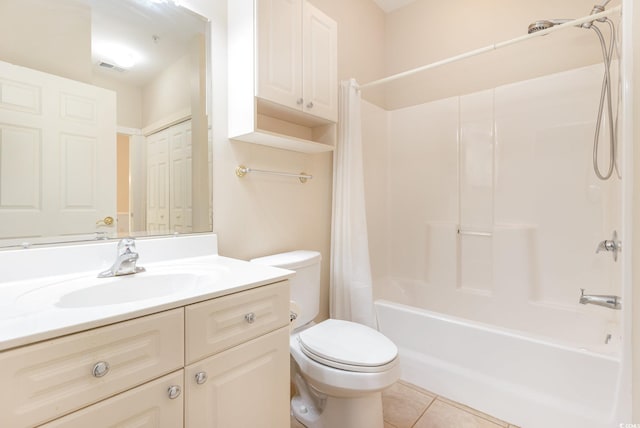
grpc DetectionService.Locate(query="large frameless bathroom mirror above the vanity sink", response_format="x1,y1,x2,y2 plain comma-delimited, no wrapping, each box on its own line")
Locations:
0,0,212,248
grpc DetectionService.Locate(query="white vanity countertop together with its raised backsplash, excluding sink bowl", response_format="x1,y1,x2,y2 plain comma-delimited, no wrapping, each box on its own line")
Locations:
0,234,293,351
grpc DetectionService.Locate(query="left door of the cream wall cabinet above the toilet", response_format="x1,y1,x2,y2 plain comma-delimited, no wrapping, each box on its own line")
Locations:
256,0,302,109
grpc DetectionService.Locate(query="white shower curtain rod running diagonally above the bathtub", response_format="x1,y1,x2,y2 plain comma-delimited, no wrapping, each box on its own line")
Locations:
360,6,622,89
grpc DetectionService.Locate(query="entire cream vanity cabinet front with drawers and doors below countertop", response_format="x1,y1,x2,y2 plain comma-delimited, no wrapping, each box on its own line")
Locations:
0,280,289,428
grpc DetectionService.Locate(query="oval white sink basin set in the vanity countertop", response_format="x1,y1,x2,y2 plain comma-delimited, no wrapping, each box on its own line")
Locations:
15,269,220,312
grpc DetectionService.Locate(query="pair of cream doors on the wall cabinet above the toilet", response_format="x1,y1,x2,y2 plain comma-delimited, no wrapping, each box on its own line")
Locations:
256,0,338,122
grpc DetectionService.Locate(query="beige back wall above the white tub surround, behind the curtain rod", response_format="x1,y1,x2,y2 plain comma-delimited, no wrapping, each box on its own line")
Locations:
380,0,620,109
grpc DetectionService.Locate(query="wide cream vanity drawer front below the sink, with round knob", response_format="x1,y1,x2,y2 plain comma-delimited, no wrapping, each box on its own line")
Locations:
0,308,184,428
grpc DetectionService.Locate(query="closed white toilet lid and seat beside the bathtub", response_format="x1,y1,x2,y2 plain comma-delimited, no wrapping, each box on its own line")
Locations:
298,319,398,372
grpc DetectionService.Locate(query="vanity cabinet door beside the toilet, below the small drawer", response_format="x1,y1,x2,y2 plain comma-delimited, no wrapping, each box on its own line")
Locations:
185,327,290,428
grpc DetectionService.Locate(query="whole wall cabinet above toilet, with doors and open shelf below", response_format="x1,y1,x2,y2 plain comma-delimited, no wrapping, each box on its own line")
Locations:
229,0,338,153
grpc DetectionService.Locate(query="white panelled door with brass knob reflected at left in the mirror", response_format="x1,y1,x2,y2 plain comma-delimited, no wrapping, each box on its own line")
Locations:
0,61,116,238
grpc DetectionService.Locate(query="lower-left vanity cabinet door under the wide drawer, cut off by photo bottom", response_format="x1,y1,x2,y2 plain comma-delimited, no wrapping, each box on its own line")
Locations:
41,370,184,428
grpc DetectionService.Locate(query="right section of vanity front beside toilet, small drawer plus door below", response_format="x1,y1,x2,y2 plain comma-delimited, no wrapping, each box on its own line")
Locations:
185,281,290,428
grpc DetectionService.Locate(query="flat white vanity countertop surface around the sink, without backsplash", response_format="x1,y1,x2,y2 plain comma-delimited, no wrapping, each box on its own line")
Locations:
0,234,294,351
